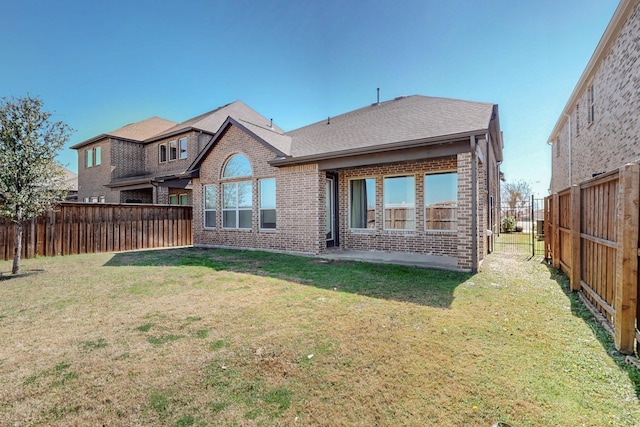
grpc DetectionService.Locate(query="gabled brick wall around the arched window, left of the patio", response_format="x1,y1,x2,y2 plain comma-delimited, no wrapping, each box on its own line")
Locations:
192,126,324,254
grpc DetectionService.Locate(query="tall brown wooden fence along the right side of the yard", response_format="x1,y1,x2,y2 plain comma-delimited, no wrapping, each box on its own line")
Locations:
545,164,640,354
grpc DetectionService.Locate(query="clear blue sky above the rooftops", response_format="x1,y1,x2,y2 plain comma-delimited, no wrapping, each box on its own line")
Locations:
0,0,618,196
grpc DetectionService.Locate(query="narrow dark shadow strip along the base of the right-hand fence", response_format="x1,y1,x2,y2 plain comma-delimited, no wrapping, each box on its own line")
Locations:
543,261,640,398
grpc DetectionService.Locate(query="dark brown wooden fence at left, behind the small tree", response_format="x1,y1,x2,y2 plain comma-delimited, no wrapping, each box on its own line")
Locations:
0,203,193,261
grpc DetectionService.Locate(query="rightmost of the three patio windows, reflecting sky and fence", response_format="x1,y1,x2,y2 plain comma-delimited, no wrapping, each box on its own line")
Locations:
424,172,458,230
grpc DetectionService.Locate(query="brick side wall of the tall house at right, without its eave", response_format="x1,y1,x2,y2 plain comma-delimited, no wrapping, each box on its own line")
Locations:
551,2,640,193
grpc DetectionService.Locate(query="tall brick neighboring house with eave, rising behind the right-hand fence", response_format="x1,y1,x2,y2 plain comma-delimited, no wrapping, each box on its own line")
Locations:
549,0,640,193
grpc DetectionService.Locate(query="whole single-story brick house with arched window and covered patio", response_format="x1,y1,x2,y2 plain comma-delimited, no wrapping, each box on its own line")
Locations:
188,95,503,271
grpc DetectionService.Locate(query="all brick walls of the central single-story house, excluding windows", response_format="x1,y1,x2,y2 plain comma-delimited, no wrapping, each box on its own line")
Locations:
192,126,487,271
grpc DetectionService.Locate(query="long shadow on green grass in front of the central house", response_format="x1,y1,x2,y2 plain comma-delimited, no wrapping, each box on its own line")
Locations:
106,248,472,308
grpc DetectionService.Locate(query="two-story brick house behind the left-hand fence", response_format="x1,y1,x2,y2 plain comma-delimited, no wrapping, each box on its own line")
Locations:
71,101,281,205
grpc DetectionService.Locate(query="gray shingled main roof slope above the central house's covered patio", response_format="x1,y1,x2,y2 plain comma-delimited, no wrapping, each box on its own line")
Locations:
286,95,494,159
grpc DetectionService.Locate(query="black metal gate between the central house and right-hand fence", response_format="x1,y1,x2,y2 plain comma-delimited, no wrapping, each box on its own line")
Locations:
493,196,544,256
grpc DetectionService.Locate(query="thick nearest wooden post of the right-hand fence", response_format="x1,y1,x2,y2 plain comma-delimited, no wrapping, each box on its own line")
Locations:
614,164,640,354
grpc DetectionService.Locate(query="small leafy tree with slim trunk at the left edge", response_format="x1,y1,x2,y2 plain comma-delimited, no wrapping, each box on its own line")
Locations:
0,96,71,274
